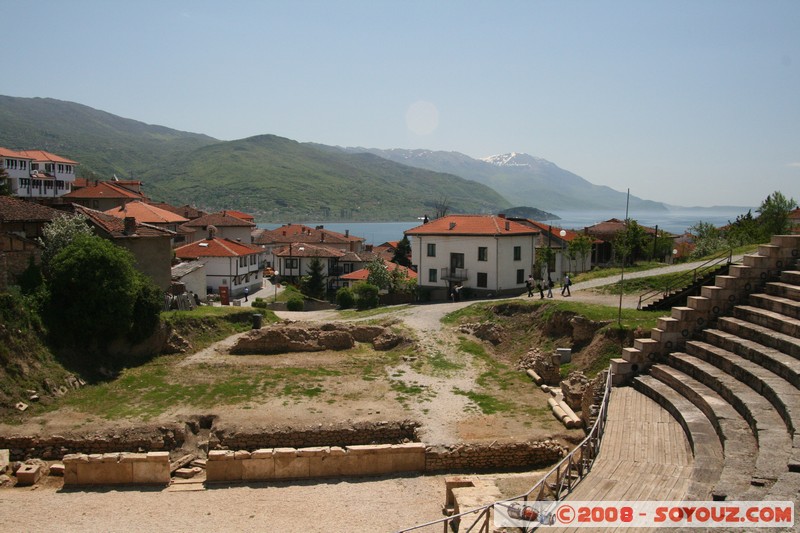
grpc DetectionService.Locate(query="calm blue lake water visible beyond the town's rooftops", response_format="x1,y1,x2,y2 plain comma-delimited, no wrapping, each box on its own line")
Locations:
258,207,755,245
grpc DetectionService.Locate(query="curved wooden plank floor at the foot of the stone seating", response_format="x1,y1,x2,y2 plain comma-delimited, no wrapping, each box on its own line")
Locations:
547,387,694,533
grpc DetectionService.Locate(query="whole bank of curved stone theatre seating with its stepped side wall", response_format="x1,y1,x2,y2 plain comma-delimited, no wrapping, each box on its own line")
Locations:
612,236,800,500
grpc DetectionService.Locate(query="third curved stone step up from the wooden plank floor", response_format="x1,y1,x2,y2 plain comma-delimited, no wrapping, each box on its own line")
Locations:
667,352,792,486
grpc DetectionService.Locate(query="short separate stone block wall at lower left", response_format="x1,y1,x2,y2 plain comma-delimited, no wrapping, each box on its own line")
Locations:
63,452,170,486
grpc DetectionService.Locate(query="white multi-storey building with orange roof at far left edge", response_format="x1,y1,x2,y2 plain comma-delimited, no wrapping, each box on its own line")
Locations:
0,148,78,198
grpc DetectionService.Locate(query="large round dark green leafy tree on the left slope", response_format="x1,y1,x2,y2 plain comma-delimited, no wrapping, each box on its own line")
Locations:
44,235,160,355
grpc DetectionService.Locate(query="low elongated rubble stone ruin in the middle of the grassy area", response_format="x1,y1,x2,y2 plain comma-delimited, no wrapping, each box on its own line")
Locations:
230,322,407,355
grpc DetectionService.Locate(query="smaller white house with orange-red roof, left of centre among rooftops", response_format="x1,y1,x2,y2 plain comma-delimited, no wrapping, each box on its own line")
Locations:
175,235,264,298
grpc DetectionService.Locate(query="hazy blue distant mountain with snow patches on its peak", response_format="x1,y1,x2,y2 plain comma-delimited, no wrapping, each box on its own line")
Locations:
342,147,667,212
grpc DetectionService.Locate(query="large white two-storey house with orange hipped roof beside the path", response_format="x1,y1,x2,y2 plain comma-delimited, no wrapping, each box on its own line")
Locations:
405,215,540,299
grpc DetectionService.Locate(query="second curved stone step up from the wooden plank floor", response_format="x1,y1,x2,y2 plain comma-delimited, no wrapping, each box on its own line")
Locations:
650,365,760,500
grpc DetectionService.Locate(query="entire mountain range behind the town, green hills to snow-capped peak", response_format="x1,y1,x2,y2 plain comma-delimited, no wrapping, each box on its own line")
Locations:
0,96,666,222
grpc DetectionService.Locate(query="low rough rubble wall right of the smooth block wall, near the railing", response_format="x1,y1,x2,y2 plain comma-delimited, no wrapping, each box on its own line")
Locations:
425,440,569,472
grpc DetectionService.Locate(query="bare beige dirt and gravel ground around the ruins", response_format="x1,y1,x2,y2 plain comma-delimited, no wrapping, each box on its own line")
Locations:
0,290,635,532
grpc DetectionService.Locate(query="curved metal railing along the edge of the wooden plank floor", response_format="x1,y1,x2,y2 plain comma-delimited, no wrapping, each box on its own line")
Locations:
398,369,612,533
